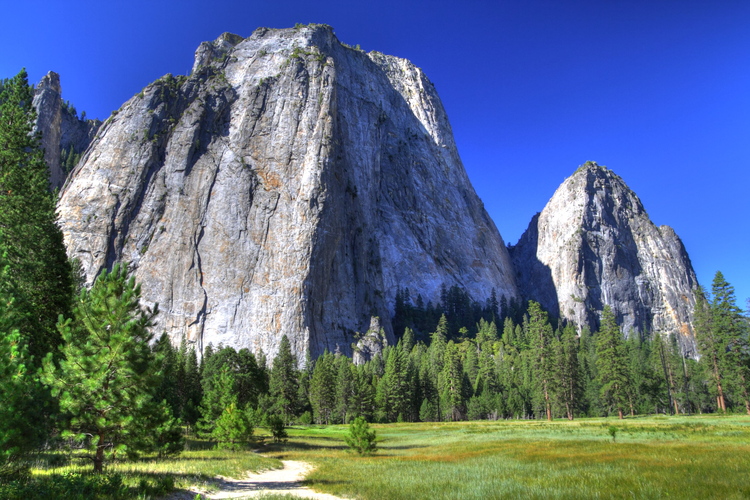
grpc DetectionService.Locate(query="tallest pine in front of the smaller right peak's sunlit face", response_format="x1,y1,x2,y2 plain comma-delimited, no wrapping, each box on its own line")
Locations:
596,306,630,418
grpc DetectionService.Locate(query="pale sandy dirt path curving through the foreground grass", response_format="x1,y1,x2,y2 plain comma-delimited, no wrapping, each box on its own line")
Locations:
170,460,343,500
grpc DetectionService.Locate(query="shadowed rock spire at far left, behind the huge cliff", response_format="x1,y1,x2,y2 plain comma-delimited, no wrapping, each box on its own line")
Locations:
33,71,101,188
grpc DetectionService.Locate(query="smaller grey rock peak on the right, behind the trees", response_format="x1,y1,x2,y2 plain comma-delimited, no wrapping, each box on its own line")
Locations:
511,162,697,354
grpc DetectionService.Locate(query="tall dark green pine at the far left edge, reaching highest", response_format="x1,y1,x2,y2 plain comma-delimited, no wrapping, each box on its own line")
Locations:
0,70,74,363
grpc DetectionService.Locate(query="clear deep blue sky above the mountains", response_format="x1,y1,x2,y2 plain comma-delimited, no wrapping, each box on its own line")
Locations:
0,0,750,308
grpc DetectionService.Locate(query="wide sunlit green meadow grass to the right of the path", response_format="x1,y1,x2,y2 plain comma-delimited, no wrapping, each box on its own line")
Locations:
267,416,750,499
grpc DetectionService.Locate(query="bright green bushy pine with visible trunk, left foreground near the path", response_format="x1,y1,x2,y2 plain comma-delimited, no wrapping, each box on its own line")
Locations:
43,264,179,472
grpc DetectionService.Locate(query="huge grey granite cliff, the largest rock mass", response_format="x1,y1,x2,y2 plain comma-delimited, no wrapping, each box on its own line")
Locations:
59,26,517,356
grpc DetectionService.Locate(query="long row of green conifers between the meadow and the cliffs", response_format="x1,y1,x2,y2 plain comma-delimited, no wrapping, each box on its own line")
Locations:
161,273,750,438
